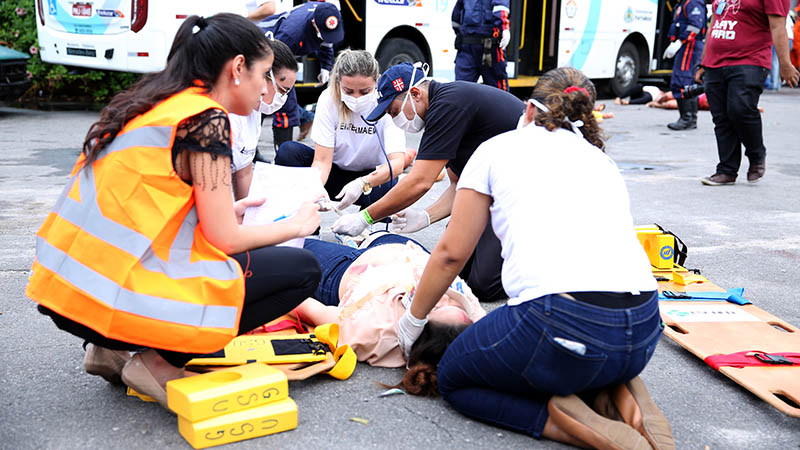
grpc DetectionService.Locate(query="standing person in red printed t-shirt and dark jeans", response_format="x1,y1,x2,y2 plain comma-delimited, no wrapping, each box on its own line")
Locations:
695,0,800,186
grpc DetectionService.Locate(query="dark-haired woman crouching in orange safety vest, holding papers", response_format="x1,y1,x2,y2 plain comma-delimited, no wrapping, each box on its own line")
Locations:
26,14,320,406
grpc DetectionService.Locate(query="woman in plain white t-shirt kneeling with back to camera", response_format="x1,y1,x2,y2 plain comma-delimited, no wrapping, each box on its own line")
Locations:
398,68,674,449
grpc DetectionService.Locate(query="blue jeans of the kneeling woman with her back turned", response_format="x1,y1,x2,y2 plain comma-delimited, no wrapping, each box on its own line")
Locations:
438,292,662,438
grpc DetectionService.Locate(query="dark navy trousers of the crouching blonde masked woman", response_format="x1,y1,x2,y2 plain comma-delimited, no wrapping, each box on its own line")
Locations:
275,141,400,208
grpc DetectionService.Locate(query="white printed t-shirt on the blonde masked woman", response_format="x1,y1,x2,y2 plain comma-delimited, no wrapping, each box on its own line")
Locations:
311,89,406,171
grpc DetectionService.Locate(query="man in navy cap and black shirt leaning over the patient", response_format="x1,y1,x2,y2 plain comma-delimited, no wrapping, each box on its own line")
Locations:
333,63,525,301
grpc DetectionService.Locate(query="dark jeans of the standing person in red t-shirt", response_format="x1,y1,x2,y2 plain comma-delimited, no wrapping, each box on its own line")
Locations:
703,65,769,177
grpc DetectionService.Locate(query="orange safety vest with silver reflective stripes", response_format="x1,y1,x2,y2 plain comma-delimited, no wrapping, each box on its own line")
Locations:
26,88,244,353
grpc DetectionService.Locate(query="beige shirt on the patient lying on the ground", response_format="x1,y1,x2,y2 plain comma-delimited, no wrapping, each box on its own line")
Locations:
337,242,486,367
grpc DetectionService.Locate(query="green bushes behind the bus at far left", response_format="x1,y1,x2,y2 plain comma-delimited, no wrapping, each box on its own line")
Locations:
0,0,138,103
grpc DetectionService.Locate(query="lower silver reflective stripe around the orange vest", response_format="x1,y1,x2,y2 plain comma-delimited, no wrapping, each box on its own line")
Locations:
36,237,239,328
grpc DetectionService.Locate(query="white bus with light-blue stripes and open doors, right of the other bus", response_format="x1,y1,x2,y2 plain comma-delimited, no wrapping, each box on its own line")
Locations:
356,0,678,93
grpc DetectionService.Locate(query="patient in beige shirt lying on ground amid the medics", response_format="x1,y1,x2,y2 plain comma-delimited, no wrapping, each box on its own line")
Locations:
295,232,486,367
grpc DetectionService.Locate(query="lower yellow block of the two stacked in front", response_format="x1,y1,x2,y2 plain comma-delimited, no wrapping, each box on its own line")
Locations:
178,398,297,448
